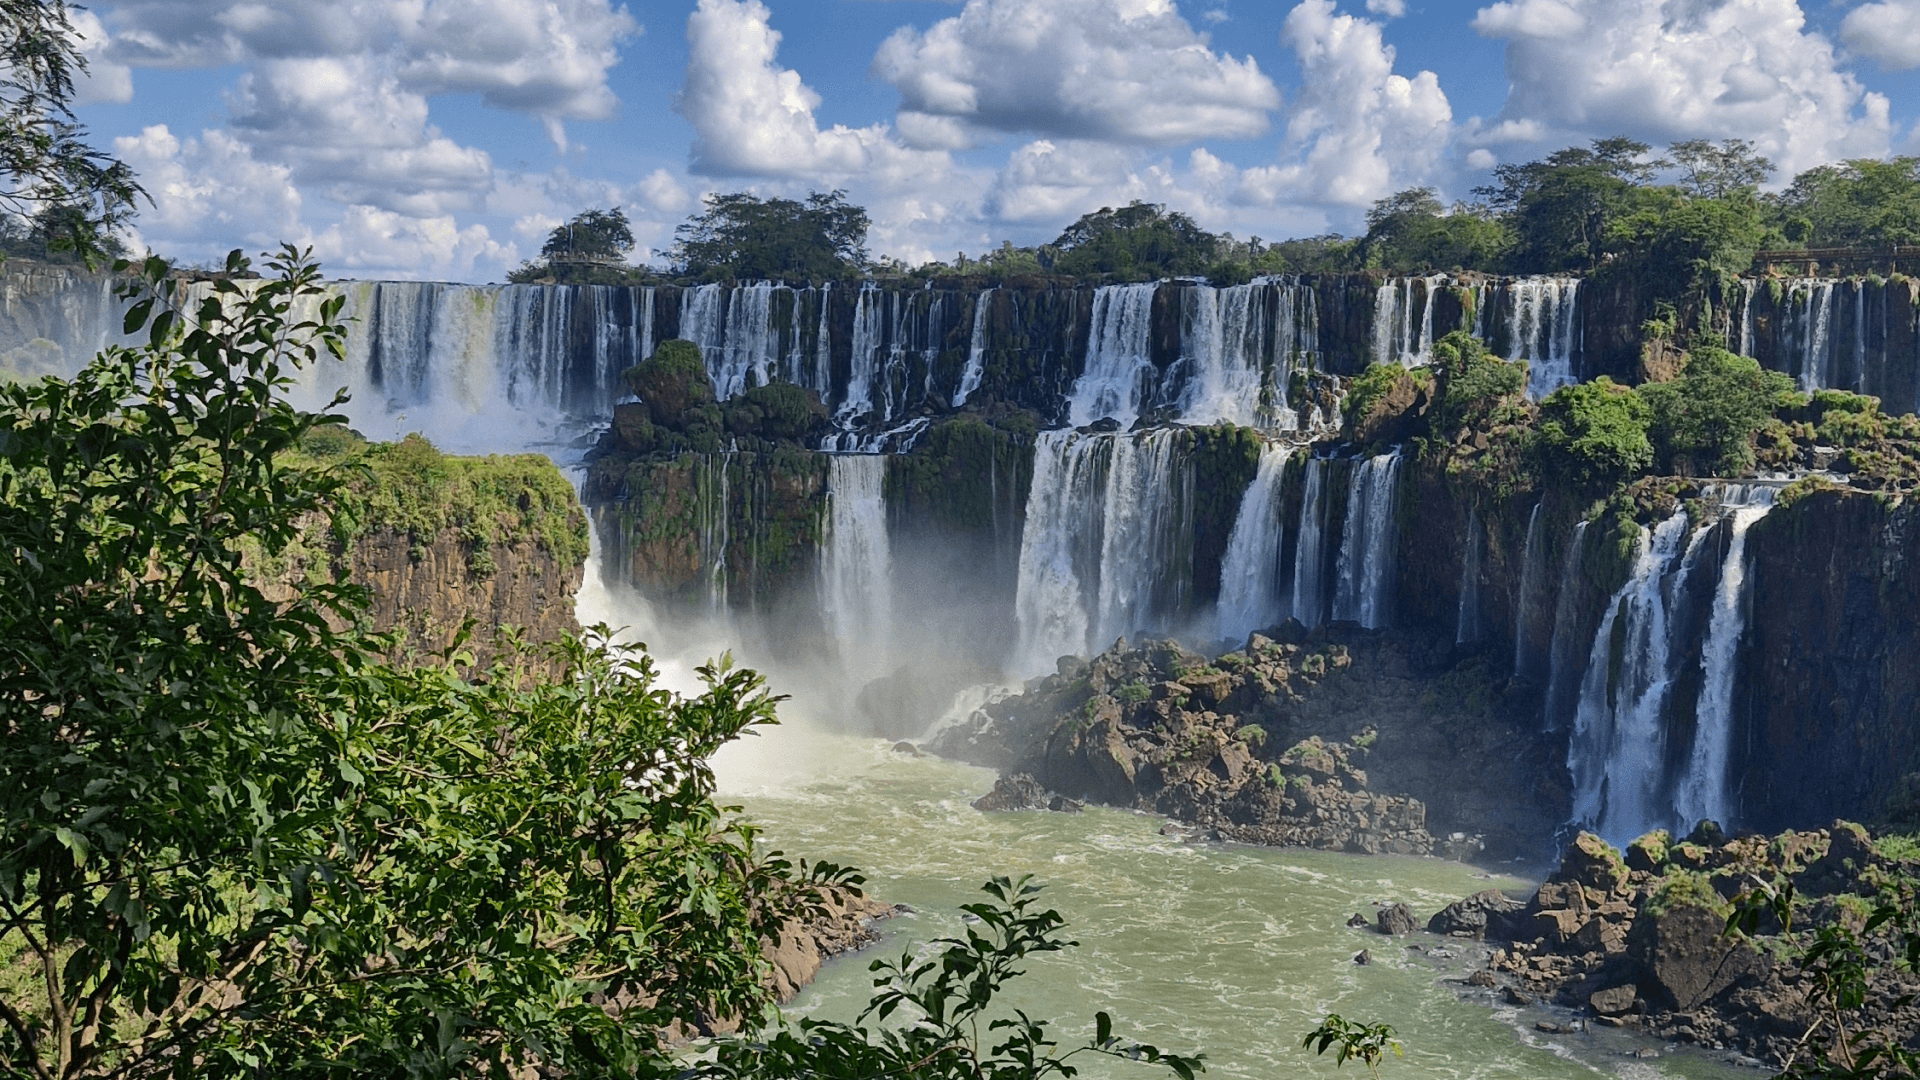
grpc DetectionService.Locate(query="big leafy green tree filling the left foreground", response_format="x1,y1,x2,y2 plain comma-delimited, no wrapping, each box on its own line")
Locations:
0,250,845,1080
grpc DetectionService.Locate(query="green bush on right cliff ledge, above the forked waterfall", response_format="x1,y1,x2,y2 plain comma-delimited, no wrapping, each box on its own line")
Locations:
1638,344,1795,477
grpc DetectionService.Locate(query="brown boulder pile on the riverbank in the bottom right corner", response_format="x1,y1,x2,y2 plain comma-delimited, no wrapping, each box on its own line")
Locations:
1434,822,1920,1063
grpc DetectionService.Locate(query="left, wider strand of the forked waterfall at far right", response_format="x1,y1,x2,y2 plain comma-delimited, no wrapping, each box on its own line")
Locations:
1567,509,1711,844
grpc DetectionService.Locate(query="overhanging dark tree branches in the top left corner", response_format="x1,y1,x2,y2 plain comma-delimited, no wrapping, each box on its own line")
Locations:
0,0,146,261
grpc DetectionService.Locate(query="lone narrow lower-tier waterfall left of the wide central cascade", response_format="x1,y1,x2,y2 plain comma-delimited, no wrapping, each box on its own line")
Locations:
820,454,893,682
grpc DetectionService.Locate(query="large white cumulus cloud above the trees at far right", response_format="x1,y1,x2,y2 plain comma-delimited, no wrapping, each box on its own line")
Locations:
1465,0,1889,175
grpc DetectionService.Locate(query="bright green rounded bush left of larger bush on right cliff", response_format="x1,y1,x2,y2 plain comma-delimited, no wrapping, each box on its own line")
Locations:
1528,375,1653,488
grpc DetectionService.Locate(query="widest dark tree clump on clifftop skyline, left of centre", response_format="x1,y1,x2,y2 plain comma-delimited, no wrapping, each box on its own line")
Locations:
674,190,868,281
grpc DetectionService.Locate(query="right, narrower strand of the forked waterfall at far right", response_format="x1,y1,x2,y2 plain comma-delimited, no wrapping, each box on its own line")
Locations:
1674,484,1776,828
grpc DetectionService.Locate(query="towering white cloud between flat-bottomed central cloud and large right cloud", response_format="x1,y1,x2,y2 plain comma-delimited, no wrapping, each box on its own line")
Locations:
1236,0,1453,206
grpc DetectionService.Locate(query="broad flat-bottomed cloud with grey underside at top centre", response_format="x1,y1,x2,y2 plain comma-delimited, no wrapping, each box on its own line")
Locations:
872,0,1281,148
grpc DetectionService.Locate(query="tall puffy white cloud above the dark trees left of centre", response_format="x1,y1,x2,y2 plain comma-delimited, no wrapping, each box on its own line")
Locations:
674,0,947,179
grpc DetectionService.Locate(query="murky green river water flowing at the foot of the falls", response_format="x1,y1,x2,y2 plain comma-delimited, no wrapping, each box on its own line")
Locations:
714,726,1755,1080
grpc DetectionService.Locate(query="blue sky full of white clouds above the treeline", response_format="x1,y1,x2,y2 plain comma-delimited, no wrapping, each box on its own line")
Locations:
77,0,1920,281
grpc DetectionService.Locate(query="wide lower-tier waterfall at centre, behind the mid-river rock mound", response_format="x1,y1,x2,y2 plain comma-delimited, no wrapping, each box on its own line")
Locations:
1014,430,1192,675
